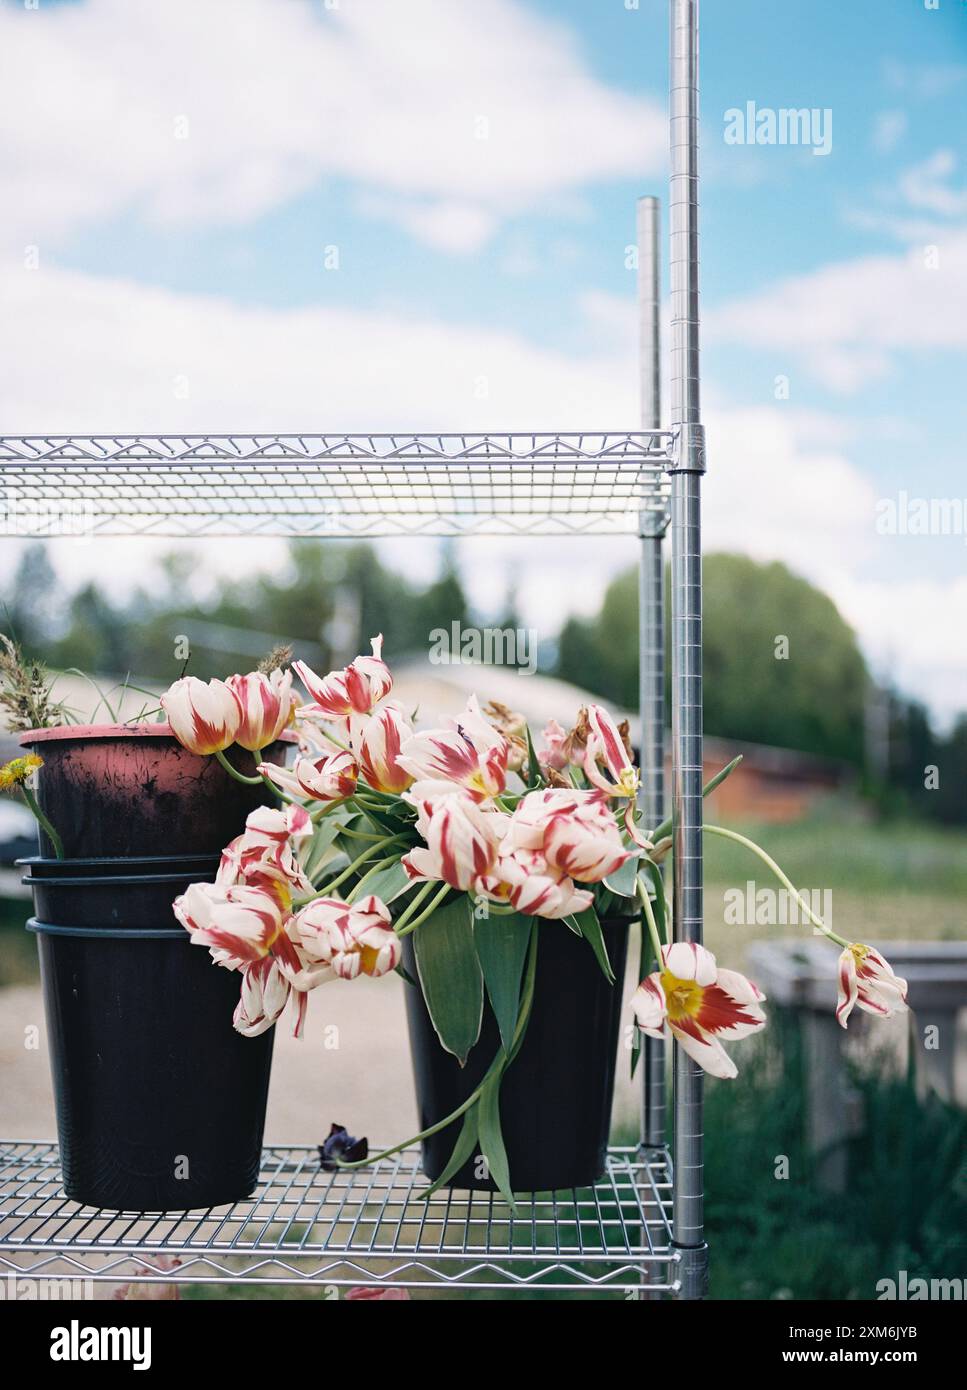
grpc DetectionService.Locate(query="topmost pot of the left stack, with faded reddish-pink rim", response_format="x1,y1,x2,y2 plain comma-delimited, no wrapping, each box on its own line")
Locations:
21,724,292,859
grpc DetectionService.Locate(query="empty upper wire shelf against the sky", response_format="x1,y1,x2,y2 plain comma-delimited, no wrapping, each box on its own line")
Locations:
0,431,672,538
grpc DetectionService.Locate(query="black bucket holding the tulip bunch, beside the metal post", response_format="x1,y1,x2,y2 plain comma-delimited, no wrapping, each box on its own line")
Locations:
403,917,629,1193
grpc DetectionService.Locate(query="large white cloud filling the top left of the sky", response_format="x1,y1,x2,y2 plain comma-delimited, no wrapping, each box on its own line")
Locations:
0,0,667,250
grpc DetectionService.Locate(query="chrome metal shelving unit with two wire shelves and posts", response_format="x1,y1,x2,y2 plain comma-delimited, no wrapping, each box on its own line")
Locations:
0,0,707,1298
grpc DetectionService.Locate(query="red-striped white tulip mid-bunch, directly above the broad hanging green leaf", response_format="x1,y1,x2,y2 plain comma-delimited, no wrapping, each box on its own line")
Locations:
402,790,510,892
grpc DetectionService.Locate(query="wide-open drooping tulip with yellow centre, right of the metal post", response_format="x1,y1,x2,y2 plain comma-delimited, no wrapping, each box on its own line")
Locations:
631,941,766,1079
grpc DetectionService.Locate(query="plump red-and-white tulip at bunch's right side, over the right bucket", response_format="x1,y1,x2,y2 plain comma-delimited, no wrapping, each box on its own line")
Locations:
504,788,631,883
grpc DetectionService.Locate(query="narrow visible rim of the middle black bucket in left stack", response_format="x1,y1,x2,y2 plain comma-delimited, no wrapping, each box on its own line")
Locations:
22,860,217,930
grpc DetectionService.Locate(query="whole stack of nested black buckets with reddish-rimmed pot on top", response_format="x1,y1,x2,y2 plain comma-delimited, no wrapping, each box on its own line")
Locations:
21,726,282,1212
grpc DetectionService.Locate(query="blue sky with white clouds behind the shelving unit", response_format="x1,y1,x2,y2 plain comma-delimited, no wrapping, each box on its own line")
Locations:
0,0,967,716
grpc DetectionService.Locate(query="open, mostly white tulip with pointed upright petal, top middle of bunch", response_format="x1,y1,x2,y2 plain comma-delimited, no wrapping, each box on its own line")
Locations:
399,695,510,801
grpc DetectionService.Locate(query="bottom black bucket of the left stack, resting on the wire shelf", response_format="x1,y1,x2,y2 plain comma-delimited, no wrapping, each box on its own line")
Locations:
28,919,274,1212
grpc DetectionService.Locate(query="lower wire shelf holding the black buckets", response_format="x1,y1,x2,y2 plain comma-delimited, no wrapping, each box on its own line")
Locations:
0,1141,679,1294
